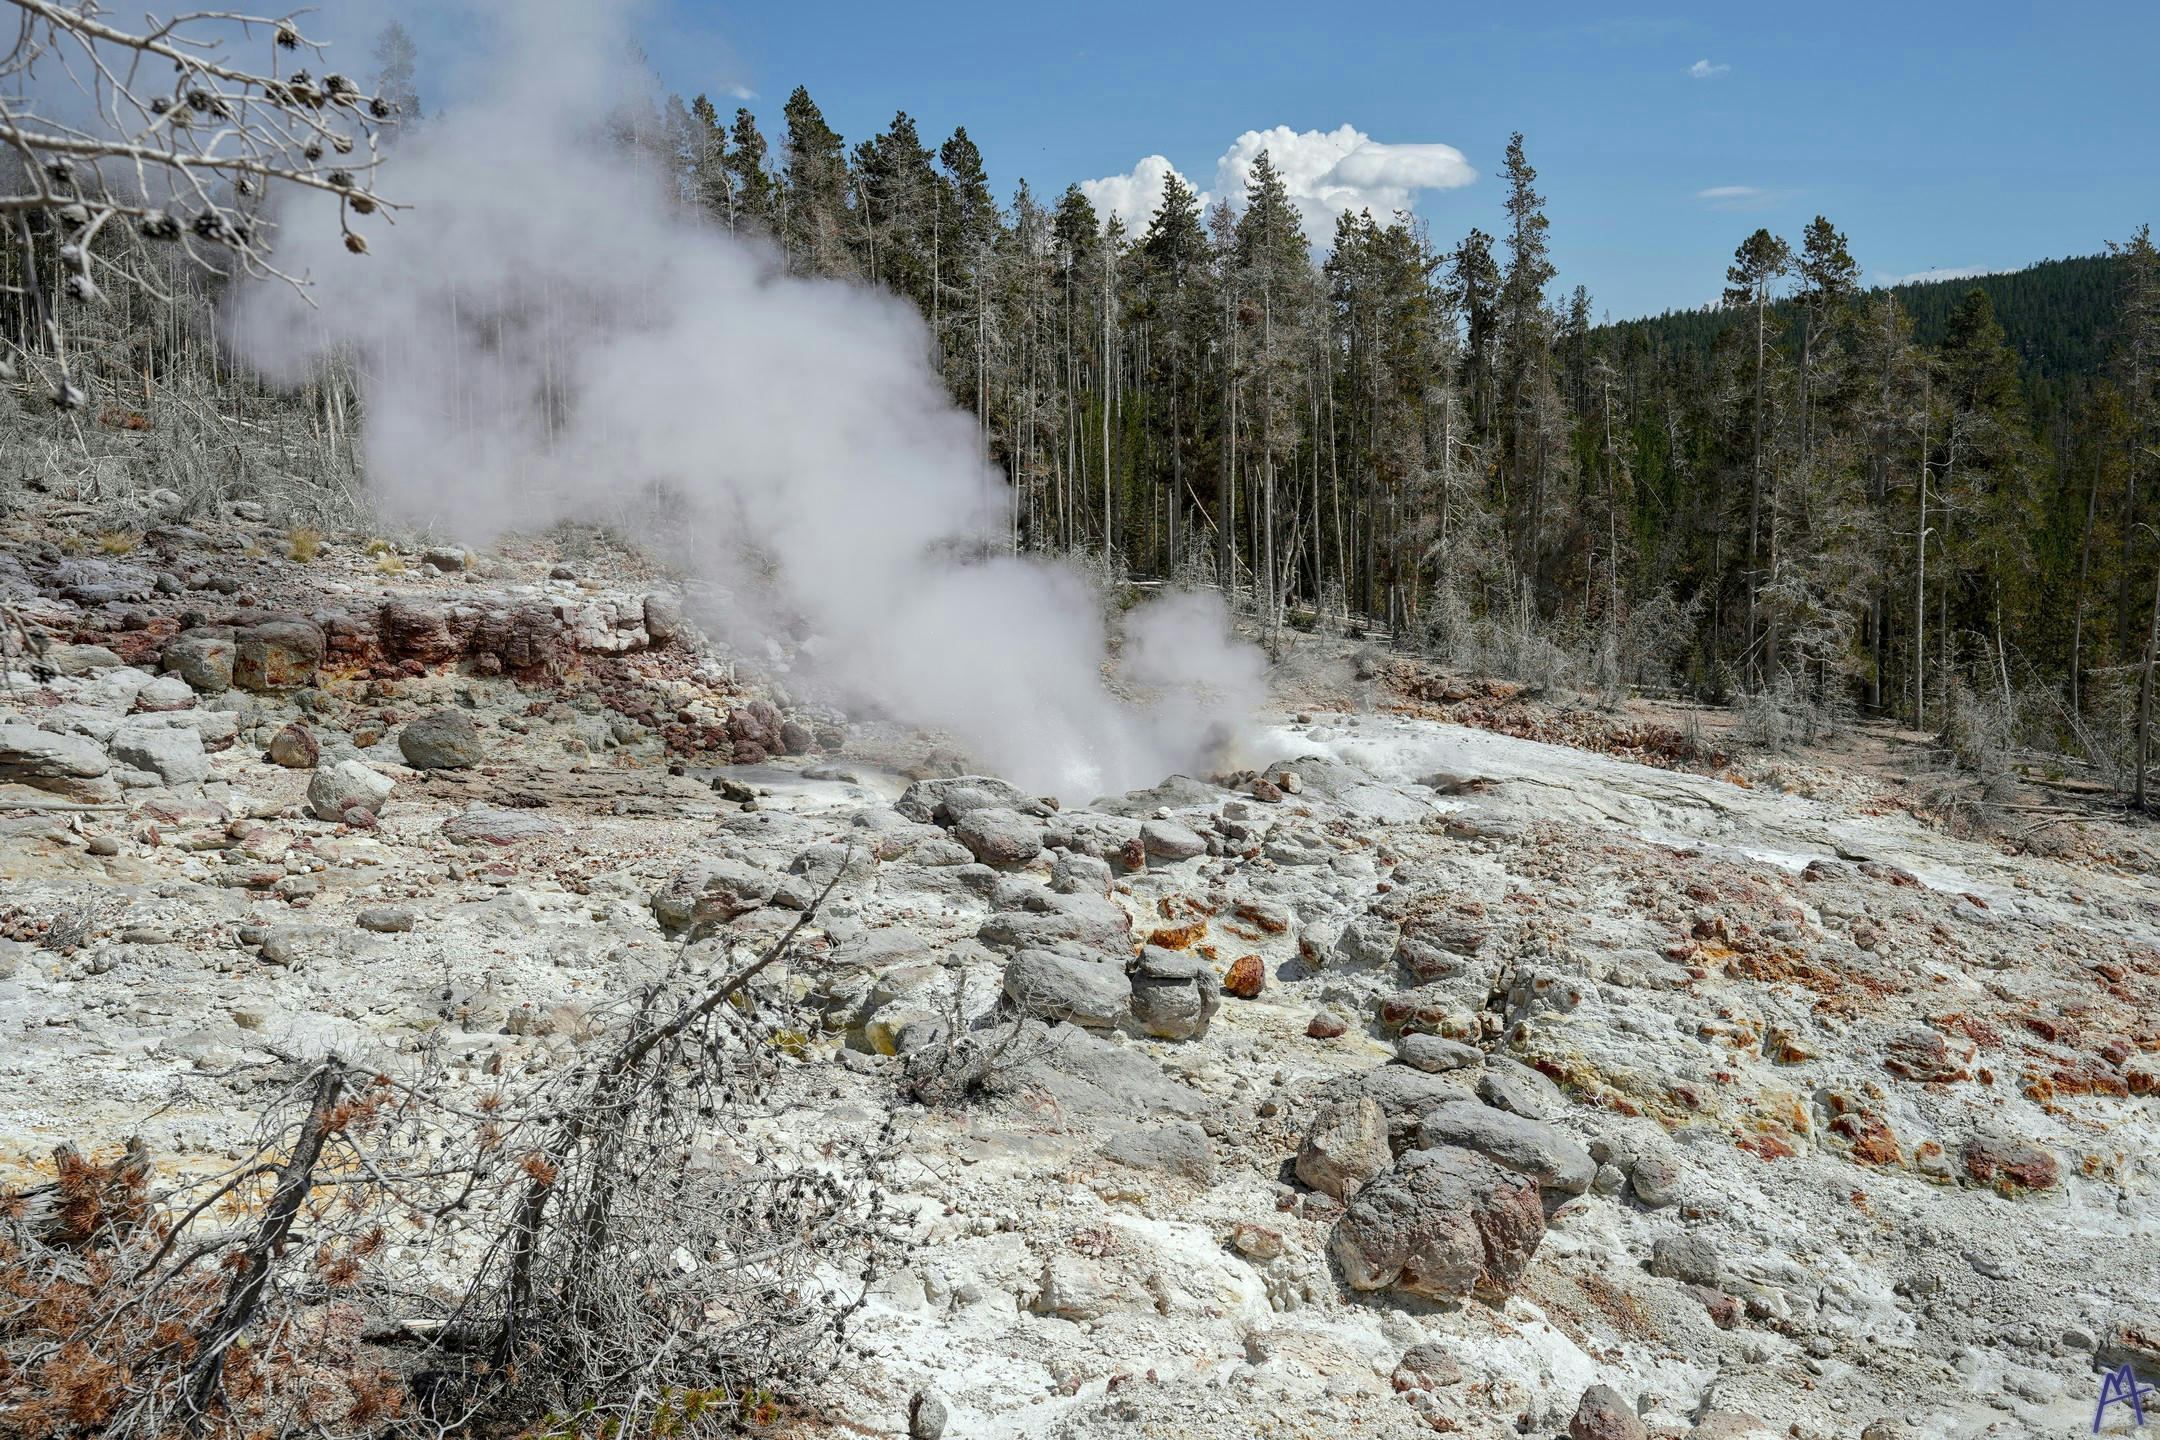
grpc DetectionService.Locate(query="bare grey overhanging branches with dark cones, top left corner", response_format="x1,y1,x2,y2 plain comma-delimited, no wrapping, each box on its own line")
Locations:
0,0,395,410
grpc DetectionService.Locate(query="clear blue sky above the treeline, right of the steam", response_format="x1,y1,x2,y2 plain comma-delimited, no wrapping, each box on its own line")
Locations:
384,0,2160,317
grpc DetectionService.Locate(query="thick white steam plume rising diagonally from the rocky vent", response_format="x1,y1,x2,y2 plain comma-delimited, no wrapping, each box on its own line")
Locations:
233,0,1264,799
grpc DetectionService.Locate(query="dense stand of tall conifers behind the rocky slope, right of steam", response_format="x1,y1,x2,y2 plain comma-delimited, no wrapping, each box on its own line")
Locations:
11,50,2160,781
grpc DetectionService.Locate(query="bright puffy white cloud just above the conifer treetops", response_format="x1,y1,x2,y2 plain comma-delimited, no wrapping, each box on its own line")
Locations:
1080,125,1477,246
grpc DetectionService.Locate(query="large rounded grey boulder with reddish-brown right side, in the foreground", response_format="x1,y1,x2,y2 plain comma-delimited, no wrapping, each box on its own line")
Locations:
1328,1146,1544,1300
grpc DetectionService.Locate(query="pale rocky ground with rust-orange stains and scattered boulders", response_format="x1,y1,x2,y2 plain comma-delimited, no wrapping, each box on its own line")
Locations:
0,505,2160,1440
